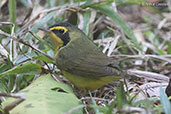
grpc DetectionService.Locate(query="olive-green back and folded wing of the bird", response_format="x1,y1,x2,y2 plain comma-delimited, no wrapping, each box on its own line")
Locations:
56,28,120,78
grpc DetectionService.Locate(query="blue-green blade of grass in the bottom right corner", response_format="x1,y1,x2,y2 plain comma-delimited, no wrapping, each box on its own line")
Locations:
160,87,171,114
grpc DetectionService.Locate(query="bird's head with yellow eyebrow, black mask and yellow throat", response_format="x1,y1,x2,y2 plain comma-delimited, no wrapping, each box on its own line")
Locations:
39,22,84,53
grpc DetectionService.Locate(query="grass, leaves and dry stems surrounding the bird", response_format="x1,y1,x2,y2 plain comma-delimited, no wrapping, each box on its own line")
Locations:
0,0,171,114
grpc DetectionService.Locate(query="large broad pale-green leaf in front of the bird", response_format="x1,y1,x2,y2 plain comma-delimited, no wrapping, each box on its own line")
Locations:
3,75,83,114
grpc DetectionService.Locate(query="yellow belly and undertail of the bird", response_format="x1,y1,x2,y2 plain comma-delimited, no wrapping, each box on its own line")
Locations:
62,71,121,91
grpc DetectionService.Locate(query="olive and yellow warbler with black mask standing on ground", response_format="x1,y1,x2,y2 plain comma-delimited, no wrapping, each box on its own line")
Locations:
39,22,121,90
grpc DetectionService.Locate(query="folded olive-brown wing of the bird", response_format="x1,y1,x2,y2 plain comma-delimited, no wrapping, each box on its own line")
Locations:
58,45,120,77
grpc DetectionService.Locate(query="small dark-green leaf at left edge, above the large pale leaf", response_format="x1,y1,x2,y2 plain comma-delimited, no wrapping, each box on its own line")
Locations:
0,63,41,78
